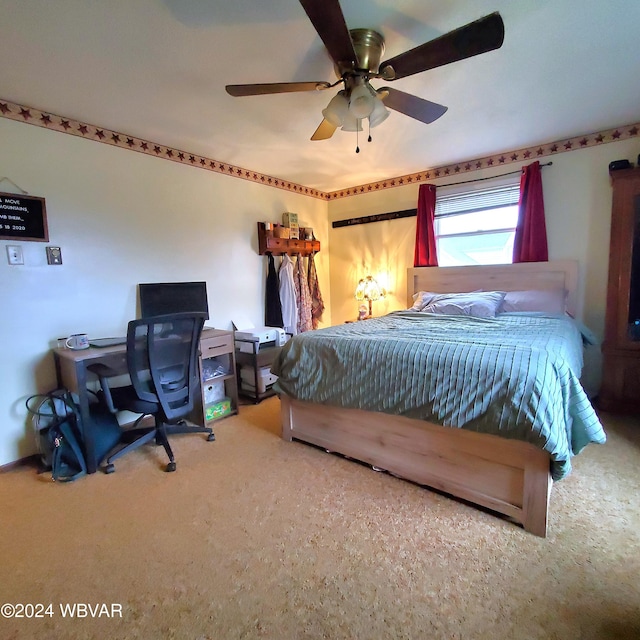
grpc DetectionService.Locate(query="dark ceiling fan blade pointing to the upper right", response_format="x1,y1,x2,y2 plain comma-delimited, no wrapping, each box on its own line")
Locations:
380,12,504,80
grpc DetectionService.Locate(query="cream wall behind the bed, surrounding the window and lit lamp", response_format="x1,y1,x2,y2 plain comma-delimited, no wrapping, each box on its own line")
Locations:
329,139,640,393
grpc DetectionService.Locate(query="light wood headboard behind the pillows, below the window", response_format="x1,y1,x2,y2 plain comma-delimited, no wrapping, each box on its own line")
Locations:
407,260,578,316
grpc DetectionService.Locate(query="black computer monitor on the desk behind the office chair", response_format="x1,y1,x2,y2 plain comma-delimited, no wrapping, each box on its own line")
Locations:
138,282,209,318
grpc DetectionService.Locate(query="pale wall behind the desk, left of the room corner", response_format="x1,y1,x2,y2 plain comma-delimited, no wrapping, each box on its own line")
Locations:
0,118,331,465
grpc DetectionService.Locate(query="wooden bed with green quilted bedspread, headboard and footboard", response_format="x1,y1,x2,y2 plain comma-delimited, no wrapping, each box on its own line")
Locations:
272,261,605,537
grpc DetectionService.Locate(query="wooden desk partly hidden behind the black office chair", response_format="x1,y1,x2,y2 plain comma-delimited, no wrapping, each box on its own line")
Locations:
53,328,238,473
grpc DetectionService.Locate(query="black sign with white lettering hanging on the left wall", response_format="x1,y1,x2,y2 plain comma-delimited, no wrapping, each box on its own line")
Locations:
0,191,49,242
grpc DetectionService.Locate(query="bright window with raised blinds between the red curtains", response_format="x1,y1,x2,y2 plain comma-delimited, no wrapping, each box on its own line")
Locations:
435,183,520,267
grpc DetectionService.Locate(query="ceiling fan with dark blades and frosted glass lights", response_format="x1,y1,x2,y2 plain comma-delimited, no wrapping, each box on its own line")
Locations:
226,0,504,152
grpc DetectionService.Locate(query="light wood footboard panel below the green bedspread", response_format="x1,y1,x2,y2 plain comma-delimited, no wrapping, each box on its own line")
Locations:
280,394,552,537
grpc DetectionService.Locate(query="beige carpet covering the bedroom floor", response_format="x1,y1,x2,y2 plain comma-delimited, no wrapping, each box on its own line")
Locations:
0,398,640,640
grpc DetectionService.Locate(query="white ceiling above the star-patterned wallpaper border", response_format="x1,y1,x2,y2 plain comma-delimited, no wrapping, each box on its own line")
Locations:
0,0,640,191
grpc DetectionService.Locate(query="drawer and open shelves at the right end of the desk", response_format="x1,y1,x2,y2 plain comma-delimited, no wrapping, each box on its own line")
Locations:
200,329,238,427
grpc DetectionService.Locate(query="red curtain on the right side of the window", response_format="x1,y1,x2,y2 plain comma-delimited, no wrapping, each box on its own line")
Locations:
513,162,549,262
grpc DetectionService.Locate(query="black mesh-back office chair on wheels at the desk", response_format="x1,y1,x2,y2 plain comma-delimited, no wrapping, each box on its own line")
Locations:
90,313,215,473
